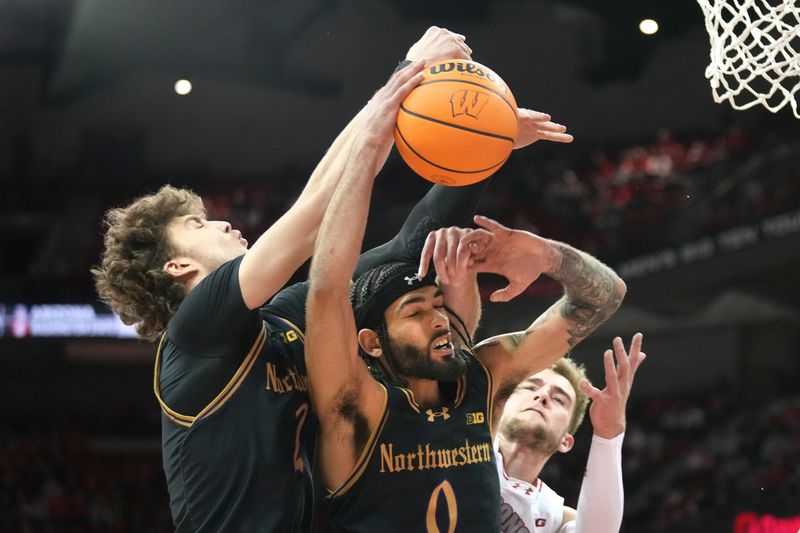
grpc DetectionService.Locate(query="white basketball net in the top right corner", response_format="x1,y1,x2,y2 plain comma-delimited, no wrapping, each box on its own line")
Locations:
697,0,800,118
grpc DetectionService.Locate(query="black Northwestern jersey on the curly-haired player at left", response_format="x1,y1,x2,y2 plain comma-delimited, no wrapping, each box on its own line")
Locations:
154,313,317,533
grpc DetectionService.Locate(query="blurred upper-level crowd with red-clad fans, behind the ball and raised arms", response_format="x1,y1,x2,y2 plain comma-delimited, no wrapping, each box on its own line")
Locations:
0,122,800,301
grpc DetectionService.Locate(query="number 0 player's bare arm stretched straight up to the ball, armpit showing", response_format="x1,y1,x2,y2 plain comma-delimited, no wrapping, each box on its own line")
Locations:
305,63,422,487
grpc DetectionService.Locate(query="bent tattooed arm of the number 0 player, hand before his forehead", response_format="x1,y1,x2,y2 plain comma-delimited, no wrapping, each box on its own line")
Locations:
466,216,626,414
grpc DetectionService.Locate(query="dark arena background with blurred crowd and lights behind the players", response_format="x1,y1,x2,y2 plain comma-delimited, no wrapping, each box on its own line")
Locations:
0,0,800,532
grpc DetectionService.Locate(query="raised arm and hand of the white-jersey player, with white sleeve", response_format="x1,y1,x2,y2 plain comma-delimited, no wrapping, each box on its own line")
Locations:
562,333,645,533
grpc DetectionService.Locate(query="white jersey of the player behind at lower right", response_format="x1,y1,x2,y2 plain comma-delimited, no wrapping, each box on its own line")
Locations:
495,451,564,533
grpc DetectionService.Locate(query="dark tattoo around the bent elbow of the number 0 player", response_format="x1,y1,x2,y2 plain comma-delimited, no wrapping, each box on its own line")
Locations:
552,243,625,348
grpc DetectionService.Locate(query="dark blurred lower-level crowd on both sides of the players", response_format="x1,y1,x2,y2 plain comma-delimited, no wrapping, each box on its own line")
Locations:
0,388,800,533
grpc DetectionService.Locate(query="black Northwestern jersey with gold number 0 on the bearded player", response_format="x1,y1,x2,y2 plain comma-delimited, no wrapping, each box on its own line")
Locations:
329,354,500,533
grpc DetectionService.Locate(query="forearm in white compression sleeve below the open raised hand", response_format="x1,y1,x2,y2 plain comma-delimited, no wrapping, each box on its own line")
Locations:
575,434,625,533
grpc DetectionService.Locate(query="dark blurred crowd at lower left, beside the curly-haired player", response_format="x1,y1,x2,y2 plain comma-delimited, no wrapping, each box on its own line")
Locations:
0,414,172,533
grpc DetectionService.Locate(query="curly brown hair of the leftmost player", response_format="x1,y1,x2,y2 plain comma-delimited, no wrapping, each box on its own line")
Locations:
91,185,205,340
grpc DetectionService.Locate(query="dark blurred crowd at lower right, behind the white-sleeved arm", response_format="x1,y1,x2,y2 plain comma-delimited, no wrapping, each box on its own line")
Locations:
541,388,800,533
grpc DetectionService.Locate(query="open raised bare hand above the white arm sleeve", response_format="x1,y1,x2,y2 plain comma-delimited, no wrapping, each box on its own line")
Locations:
580,333,646,439
